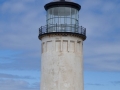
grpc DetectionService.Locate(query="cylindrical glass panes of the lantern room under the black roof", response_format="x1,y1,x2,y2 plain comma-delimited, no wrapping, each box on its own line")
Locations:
46,6,79,32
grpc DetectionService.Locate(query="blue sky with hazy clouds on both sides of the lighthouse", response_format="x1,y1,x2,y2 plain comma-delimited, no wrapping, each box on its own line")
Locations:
0,0,120,90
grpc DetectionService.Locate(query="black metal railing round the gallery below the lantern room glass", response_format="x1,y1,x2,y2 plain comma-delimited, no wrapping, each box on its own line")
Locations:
39,24,86,36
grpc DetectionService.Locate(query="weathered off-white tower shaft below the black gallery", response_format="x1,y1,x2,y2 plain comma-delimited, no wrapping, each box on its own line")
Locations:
40,35,83,90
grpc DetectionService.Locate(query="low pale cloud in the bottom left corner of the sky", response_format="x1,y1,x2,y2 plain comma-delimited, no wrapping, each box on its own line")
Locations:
0,79,39,90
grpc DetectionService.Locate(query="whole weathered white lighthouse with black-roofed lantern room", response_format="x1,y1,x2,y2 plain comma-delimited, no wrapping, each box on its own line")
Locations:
38,0,86,90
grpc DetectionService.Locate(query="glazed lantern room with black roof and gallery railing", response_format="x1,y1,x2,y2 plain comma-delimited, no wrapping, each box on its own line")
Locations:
39,0,86,39
